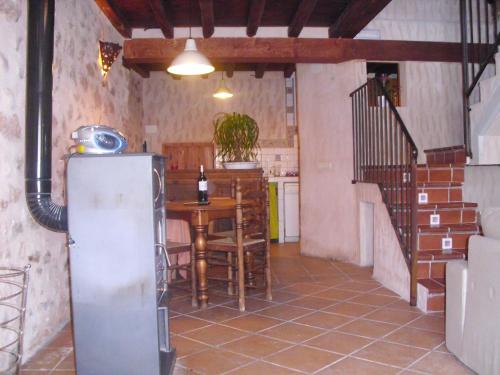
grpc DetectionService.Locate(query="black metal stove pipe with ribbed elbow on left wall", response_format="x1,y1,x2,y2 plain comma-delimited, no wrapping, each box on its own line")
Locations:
25,0,68,232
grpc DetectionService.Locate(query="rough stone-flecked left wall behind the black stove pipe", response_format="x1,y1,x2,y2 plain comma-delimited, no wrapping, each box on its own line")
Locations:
0,0,143,357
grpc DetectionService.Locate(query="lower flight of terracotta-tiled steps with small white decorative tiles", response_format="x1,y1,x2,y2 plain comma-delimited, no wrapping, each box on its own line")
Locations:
416,146,480,312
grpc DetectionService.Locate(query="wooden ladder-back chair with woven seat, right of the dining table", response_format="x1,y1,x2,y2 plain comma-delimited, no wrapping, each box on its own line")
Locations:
207,178,272,311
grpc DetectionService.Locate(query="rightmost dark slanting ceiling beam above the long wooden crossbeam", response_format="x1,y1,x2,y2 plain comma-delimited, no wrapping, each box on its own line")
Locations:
328,0,391,38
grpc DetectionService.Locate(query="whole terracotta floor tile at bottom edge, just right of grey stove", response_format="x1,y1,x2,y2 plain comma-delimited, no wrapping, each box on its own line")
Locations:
179,349,252,375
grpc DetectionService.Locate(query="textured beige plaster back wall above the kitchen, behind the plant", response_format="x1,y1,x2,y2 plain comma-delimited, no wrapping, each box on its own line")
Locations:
143,72,287,152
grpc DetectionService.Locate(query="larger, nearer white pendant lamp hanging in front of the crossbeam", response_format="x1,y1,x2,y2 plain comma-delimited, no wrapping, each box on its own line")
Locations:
167,0,215,76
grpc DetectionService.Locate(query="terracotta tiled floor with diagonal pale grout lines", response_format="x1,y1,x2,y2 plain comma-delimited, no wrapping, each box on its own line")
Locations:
21,245,473,375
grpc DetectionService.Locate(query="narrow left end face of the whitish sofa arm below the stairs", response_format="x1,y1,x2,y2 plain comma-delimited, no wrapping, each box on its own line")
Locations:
446,260,467,357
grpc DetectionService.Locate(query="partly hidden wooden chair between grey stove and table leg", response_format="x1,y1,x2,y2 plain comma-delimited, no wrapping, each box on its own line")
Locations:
167,241,198,303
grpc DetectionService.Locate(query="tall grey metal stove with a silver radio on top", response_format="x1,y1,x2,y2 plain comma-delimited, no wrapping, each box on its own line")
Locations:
67,153,175,375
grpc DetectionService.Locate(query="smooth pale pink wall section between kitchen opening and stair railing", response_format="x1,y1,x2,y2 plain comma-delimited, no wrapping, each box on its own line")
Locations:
297,61,366,261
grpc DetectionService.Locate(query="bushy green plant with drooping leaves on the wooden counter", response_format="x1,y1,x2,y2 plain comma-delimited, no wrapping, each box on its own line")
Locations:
213,112,259,162
